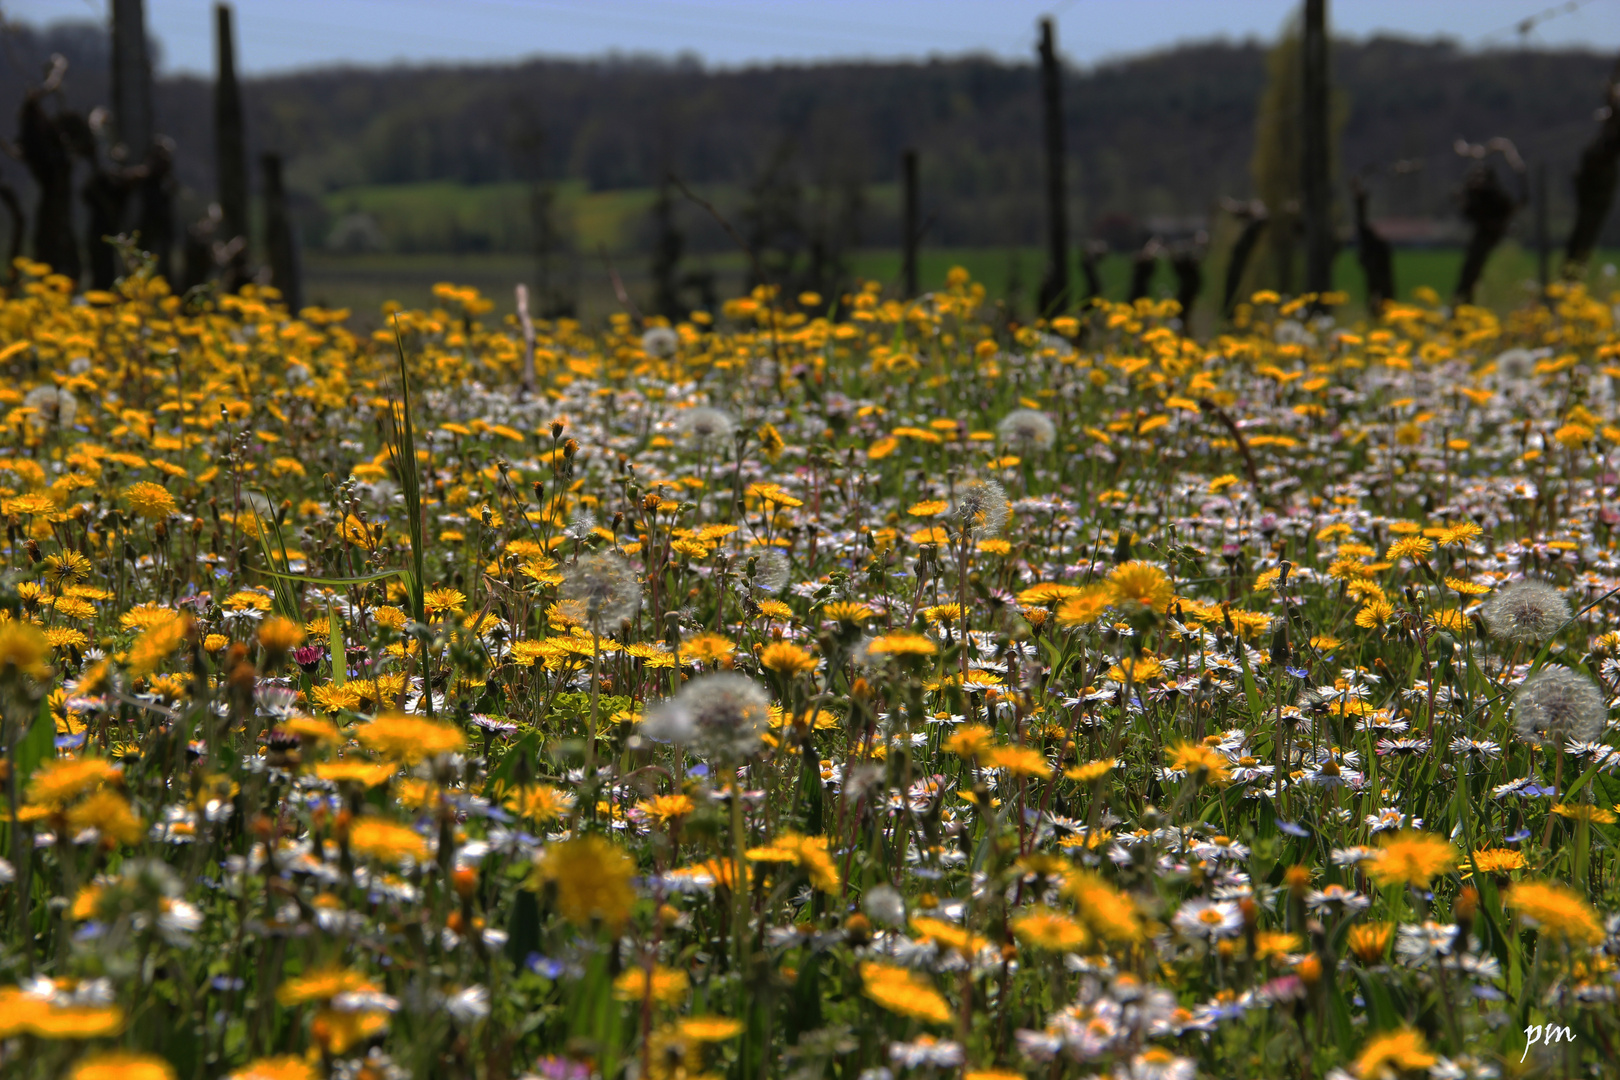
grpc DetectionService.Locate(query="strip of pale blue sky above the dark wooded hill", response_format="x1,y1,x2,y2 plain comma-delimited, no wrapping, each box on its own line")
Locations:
0,0,1620,73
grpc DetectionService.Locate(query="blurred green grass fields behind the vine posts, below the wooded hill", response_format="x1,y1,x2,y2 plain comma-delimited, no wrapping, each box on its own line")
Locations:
305,181,1620,332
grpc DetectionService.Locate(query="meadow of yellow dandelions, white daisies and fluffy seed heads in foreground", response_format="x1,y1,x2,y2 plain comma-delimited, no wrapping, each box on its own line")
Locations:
0,261,1620,1080
